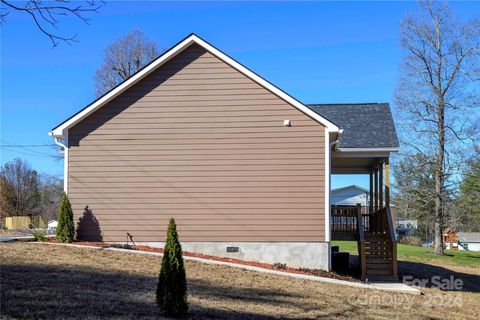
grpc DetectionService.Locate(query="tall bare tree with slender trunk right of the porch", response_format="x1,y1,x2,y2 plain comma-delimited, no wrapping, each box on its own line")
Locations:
396,1,480,254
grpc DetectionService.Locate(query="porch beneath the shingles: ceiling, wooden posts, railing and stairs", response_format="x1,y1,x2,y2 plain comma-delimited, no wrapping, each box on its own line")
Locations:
330,150,398,281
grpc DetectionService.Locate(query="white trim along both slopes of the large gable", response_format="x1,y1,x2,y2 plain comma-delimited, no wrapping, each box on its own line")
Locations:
49,34,339,137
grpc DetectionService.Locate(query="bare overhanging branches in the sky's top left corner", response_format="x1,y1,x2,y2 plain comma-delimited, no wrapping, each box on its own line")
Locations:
0,0,104,47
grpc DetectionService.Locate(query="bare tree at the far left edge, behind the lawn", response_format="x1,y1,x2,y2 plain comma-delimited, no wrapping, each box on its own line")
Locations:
0,158,40,216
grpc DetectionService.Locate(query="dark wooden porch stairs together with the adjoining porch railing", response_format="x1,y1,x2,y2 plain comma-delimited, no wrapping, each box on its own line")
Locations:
333,206,398,281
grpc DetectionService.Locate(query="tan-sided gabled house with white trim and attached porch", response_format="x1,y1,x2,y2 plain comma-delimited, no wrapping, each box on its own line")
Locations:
49,34,398,278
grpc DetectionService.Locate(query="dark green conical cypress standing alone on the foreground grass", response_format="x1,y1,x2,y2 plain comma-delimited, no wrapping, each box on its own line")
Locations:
157,218,188,317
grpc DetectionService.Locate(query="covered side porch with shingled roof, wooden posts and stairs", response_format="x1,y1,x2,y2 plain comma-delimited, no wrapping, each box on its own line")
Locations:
308,103,399,280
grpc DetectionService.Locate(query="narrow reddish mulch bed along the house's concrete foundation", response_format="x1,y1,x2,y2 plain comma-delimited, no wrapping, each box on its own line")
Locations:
47,238,360,282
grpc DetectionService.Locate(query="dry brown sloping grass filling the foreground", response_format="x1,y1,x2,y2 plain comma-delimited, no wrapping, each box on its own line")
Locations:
0,243,480,319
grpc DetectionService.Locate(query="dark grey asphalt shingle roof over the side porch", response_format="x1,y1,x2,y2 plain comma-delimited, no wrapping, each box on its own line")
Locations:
307,103,399,148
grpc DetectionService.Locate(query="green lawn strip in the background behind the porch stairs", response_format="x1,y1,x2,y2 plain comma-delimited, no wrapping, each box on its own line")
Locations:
332,241,480,268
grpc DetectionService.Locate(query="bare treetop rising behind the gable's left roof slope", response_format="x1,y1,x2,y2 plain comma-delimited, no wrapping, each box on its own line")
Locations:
94,30,158,97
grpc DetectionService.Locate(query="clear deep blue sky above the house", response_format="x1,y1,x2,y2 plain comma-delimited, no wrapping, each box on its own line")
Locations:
0,1,480,188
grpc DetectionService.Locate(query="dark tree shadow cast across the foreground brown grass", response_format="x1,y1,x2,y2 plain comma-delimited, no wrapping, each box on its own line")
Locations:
0,264,348,319
